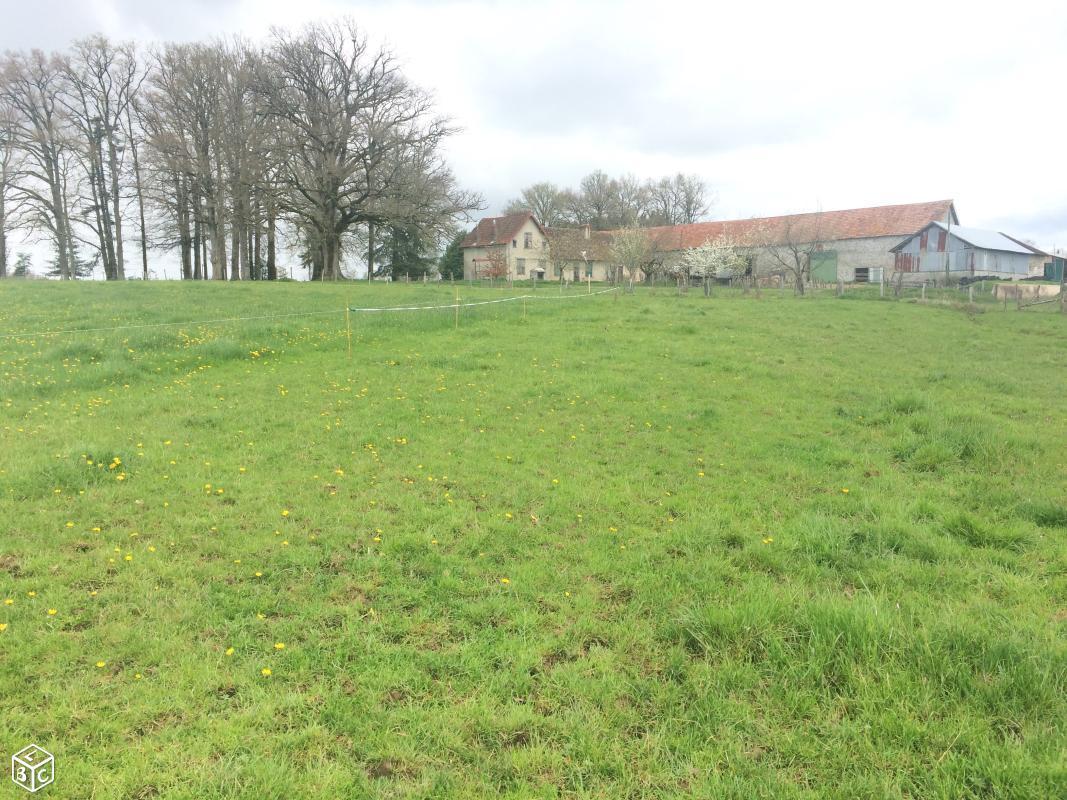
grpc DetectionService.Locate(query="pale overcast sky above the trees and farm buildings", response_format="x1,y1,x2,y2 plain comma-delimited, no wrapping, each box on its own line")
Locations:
6,0,1067,247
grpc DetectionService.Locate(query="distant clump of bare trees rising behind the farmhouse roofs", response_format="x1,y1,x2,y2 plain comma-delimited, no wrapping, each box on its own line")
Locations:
505,170,712,230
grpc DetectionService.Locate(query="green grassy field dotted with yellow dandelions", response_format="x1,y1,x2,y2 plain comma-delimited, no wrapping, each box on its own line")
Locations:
0,282,1067,800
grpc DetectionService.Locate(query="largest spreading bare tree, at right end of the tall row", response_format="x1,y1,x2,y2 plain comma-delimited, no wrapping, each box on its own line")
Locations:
257,20,480,279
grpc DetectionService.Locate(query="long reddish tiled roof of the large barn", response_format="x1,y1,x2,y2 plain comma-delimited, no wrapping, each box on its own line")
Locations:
635,199,957,251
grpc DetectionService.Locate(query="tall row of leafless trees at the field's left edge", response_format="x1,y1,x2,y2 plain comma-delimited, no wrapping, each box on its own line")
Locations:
0,19,482,279
